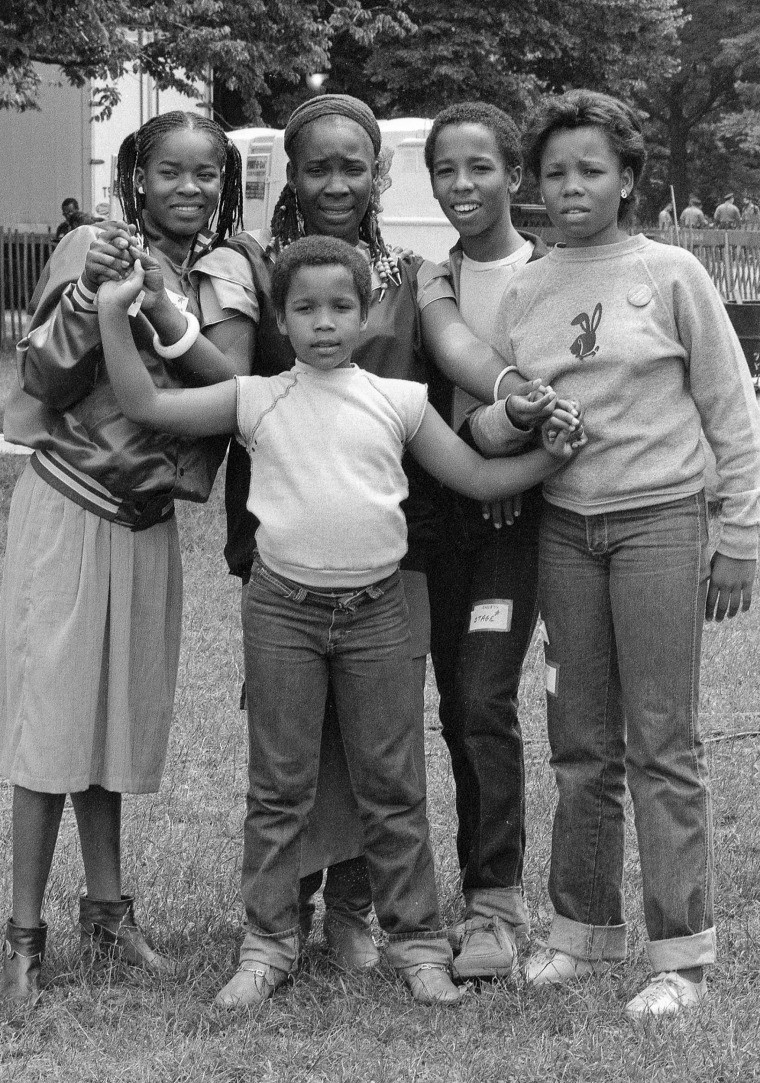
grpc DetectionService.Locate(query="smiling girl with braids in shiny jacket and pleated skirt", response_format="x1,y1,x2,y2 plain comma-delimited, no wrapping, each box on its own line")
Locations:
0,112,241,1003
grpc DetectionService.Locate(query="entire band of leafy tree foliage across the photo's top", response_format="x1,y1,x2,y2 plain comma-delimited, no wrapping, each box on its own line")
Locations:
0,0,760,212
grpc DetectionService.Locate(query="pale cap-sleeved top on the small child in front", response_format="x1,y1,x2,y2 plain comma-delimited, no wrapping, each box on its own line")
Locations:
237,361,428,589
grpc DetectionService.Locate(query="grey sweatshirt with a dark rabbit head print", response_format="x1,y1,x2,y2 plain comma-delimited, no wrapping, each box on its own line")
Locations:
470,235,760,560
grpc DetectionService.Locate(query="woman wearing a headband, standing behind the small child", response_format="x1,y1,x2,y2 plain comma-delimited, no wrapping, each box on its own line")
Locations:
193,94,552,1007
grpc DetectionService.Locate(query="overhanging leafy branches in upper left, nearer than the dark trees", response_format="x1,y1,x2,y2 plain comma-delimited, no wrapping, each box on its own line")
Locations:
0,0,411,121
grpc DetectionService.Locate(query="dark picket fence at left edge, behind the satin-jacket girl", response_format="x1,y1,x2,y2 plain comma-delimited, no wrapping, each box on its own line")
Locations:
0,225,55,348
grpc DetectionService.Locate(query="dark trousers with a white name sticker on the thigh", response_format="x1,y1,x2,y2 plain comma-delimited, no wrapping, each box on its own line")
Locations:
428,488,543,934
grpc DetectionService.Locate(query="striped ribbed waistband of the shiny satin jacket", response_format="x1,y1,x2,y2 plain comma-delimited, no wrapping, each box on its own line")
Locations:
30,451,174,531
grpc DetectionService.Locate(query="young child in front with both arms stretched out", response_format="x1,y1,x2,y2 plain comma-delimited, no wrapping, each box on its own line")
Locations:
99,236,574,1007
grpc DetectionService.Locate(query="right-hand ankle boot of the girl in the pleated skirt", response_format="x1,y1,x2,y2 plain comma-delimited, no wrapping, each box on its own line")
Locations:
79,895,174,975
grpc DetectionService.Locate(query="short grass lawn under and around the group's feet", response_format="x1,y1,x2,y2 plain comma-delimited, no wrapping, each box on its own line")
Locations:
0,354,760,1083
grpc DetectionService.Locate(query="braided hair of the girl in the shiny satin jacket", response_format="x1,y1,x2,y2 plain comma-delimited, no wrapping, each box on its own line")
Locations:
116,109,243,247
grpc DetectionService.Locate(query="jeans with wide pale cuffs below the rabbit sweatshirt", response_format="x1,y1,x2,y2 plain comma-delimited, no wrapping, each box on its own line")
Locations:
539,493,715,971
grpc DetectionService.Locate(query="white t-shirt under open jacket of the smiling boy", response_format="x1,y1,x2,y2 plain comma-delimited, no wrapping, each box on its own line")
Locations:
451,240,534,432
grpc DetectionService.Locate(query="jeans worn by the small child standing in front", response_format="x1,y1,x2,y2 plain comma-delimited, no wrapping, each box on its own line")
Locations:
243,563,440,940
